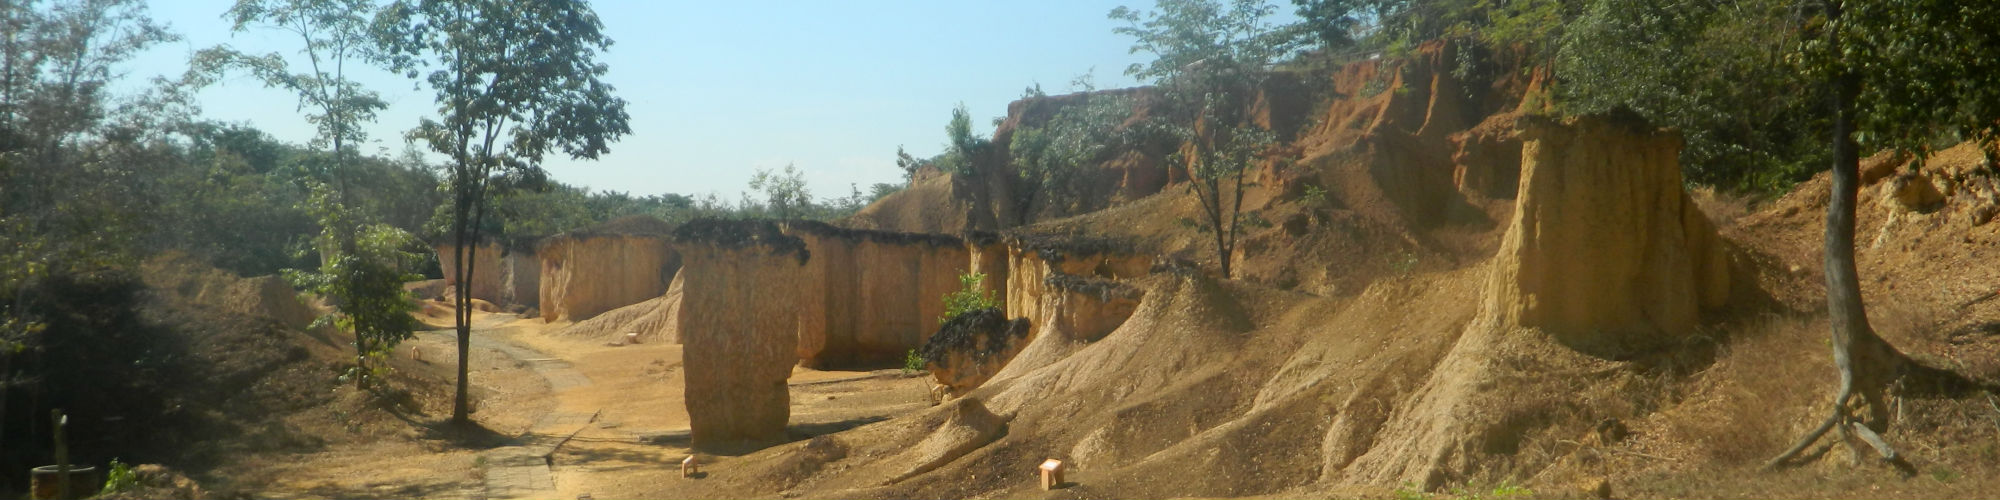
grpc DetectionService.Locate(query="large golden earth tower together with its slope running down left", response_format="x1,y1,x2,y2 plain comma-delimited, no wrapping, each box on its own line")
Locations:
1326,116,1730,488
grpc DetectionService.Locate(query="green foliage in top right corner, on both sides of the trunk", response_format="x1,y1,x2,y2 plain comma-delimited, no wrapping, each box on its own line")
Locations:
1556,0,2000,192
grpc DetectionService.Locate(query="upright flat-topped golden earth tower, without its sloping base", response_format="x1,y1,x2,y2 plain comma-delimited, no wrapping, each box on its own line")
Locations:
1488,118,1730,358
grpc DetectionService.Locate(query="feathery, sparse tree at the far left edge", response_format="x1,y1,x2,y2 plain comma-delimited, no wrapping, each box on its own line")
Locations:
0,0,178,456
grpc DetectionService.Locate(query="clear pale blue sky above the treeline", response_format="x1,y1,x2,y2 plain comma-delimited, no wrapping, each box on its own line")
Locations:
128,0,1184,200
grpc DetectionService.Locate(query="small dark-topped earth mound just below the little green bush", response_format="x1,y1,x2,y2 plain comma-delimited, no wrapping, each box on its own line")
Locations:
922,308,1030,396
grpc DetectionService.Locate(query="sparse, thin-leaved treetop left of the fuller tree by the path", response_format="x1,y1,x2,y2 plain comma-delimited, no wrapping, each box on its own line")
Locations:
192,0,388,203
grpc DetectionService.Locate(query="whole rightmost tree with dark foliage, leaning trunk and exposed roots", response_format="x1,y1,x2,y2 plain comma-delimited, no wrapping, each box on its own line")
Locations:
1766,0,2000,466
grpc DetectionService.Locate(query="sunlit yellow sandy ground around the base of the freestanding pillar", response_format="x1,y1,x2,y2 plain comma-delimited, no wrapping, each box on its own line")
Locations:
218,314,930,498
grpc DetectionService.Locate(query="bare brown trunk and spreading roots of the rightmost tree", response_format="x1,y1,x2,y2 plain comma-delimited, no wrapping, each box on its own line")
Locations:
1764,2,1906,468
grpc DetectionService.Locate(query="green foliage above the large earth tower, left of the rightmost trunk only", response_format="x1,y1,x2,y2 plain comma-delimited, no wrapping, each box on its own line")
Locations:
1554,0,1828,192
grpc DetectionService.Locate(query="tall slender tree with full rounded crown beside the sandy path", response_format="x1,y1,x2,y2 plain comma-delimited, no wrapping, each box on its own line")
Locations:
376,0,630,424
